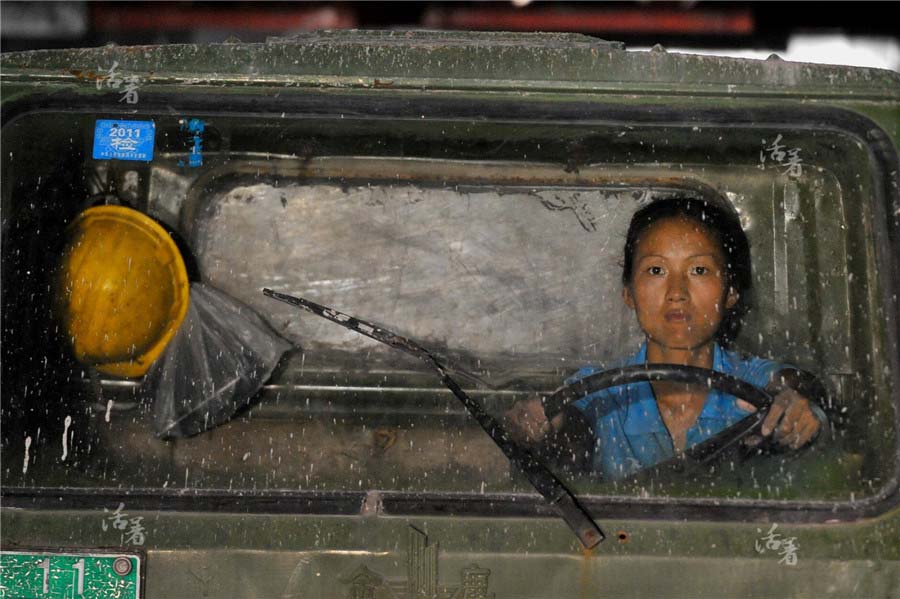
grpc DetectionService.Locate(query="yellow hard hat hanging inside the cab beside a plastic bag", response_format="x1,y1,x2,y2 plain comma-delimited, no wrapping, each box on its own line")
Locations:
56,206,190,377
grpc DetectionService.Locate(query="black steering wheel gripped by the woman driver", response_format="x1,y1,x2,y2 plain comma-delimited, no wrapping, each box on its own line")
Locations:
542,364,774,467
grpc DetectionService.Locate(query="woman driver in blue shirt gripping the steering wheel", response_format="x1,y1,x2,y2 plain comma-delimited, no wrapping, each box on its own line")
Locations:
507,199,826,479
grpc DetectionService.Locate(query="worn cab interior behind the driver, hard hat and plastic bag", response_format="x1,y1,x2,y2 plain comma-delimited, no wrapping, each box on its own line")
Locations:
2,109,896,501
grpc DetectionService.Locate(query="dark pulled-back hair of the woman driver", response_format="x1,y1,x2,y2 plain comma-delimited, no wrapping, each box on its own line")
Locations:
622,198,753,346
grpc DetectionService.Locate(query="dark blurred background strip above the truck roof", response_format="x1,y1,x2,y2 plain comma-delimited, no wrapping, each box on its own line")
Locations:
0,0,900,69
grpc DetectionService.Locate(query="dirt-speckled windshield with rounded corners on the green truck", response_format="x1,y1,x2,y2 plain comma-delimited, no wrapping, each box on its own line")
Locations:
2,105,896,502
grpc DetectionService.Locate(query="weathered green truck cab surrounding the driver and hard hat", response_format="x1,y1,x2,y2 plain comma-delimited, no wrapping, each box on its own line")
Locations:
0,31,900,599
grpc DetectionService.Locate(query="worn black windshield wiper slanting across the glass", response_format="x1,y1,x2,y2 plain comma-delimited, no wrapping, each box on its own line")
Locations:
263,289,605,548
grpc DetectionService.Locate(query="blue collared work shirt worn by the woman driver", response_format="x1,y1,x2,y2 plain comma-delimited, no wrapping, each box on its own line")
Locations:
566,343,785,480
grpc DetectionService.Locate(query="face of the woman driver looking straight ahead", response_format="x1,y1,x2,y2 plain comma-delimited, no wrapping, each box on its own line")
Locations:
624,217,738,350
